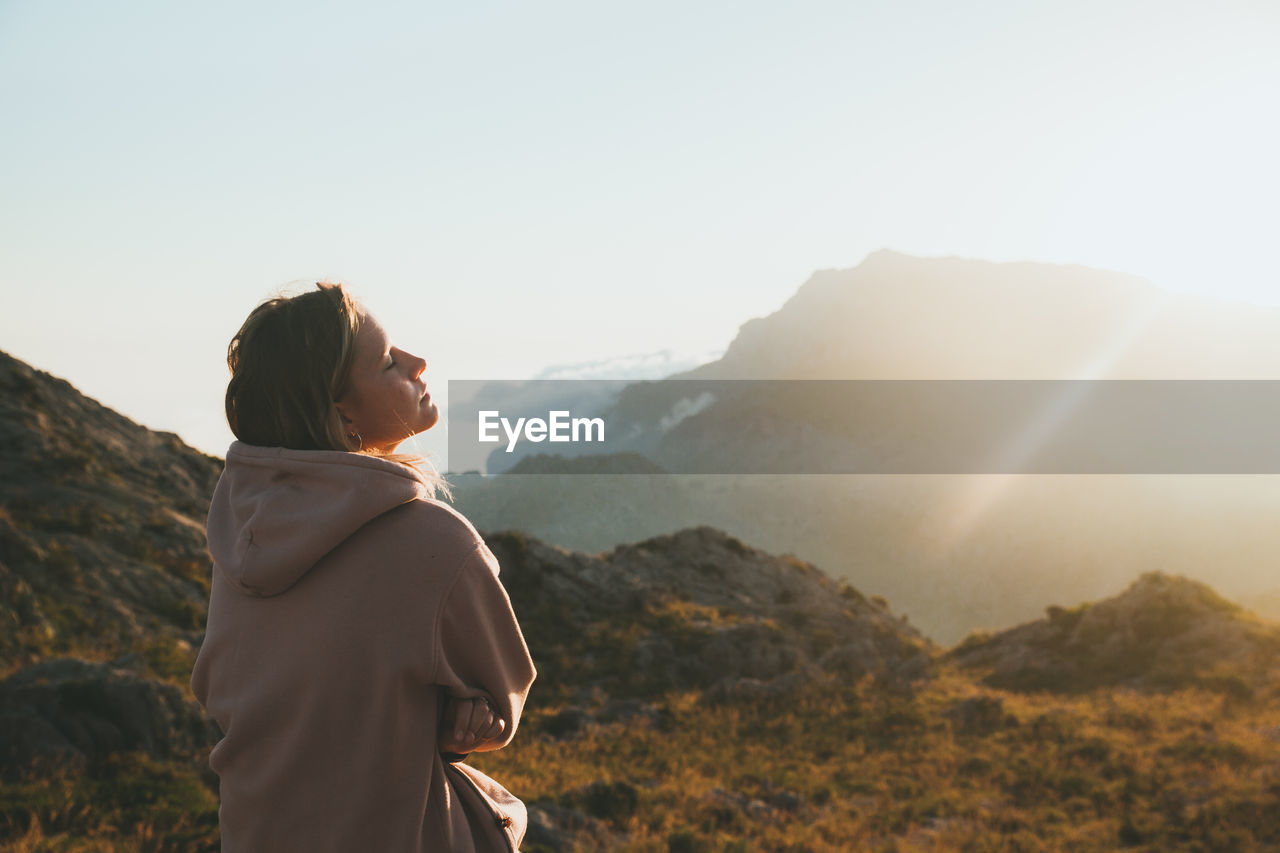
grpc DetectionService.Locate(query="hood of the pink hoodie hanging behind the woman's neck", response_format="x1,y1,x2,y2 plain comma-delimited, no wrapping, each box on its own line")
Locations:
209,441,434,597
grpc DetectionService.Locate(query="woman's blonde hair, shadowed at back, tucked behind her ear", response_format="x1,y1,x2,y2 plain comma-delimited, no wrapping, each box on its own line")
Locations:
225,282,453,500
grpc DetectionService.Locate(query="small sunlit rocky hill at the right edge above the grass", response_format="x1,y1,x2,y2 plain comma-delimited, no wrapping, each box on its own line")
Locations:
950,573,1280,695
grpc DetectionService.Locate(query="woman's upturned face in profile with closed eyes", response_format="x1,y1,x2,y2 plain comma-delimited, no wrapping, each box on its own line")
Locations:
335,311,440,453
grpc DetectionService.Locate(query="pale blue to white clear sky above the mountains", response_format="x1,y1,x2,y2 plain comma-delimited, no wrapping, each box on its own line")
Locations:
0,0,1280,466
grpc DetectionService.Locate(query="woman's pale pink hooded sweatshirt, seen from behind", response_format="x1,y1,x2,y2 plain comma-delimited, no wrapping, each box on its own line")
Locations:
191,442,535,853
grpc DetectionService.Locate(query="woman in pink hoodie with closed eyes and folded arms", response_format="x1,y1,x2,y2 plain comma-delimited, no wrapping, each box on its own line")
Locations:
192,283,535,853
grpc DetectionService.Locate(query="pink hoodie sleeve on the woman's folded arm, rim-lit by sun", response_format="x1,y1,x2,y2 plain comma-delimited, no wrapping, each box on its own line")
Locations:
434,542,536,749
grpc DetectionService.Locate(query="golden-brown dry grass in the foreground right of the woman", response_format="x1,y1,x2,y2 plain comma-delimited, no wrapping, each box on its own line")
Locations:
465,672,1280,850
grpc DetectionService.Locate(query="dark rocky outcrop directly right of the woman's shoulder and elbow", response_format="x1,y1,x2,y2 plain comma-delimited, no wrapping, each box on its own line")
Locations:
486,526,933,698
